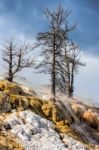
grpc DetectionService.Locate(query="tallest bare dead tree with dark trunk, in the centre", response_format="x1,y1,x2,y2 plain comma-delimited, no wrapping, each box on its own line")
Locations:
36,6,70,97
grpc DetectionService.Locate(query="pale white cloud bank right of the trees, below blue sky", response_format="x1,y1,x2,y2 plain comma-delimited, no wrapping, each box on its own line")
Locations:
75,55,99,103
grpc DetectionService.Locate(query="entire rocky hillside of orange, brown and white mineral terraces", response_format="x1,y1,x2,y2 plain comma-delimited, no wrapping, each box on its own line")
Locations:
0,80,99,150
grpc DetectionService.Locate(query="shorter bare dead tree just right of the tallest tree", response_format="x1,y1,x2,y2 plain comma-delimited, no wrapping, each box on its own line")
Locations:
59,42,85,97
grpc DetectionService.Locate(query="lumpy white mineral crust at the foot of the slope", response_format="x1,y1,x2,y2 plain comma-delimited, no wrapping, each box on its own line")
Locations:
5,110,86,150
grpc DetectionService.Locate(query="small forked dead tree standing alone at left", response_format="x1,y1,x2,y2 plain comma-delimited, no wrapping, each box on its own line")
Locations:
2,40,34,82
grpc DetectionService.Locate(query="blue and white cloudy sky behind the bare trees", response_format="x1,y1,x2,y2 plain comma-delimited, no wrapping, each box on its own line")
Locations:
0,0,99,102
